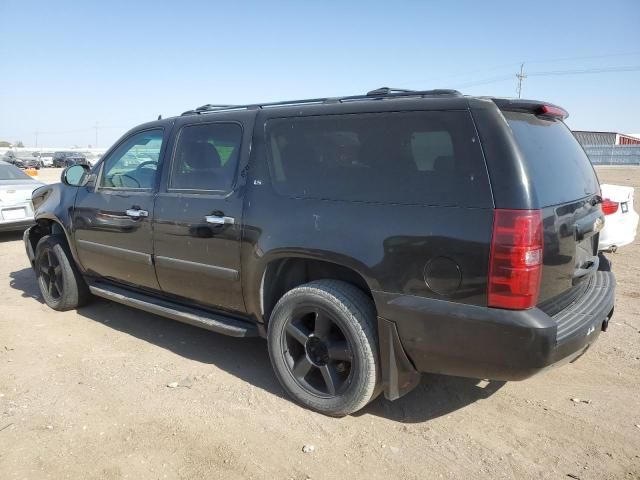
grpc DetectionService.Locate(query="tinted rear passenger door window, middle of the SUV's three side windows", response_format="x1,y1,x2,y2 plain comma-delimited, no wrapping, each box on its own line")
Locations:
169,123,242,192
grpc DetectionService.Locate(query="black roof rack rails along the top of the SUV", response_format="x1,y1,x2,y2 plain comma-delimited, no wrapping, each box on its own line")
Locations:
182,87,462,116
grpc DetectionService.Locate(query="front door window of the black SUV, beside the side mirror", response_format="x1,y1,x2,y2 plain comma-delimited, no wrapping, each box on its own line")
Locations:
100,130,162,190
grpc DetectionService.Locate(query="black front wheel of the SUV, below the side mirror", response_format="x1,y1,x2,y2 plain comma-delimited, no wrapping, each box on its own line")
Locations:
35,235,91,311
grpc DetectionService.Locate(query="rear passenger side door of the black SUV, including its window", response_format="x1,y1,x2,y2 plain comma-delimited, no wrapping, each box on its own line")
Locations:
153,114,253,311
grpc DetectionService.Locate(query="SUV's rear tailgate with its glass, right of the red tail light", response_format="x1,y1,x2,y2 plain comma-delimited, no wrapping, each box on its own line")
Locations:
503,111,604,314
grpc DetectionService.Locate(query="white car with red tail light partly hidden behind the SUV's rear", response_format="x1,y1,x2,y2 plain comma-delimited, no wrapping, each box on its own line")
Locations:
598,184,639,252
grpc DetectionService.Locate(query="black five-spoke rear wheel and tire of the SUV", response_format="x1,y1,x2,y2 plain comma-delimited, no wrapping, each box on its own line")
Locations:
267,280,380,417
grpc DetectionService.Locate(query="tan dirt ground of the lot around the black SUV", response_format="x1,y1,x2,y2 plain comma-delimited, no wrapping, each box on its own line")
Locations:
0,167,640,480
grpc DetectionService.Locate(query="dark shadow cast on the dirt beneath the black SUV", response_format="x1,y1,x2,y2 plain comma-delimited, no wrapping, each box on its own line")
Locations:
10,268,504,423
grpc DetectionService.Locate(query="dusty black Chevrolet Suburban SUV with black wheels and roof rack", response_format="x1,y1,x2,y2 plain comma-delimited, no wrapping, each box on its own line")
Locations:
24,88,615,415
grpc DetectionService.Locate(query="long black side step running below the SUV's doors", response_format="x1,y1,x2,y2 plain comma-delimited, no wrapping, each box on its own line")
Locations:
89,282,258,337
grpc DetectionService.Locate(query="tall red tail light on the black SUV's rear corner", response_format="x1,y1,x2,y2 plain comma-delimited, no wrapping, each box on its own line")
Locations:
488,209,543,310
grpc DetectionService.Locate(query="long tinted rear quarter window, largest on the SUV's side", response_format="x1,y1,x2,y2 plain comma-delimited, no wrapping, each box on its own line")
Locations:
267,111,492,207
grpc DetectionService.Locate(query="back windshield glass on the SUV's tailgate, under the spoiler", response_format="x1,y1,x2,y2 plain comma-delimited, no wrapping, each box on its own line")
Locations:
504,112,598,207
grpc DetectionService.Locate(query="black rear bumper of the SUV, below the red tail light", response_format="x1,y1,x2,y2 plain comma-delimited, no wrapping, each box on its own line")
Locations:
374,272,616,386
